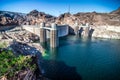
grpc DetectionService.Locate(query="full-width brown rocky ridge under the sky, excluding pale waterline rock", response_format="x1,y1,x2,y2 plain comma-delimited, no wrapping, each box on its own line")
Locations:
0,8,120,26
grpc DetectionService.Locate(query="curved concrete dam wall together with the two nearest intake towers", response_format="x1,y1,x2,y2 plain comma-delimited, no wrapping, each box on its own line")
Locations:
23,23,69,47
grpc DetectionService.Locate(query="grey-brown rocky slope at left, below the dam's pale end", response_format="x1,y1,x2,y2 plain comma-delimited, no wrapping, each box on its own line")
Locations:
0,27,39,43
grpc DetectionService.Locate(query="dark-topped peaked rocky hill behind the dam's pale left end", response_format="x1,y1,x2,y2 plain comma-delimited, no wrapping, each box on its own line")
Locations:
24,10,56,25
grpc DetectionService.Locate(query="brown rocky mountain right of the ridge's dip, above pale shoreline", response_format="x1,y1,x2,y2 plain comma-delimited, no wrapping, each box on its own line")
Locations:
56,10,120,26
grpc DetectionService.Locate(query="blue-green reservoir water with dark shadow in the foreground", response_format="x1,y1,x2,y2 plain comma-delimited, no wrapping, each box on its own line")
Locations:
42,36,120,80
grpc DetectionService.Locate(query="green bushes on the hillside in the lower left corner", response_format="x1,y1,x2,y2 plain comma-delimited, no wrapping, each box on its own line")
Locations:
0,42,36,80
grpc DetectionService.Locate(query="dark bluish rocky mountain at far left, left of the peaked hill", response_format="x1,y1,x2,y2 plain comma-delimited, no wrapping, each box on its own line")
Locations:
0,11,26,26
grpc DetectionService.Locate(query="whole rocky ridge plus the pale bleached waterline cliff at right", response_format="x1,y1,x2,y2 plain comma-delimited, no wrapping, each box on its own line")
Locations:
0,8,120,39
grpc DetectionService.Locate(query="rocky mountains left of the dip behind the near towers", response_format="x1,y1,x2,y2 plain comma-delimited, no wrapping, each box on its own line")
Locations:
0,10,56,26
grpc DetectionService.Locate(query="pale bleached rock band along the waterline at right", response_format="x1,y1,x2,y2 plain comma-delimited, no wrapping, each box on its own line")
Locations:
91,25,120,39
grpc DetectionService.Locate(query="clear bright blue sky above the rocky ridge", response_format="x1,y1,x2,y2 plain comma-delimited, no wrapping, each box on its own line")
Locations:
0,0,120,16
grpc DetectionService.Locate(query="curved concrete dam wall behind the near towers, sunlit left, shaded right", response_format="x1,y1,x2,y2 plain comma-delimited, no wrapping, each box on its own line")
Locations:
22,25,69,38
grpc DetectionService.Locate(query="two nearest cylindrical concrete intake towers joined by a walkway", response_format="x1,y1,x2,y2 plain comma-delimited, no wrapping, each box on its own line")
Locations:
40,23,59,47
